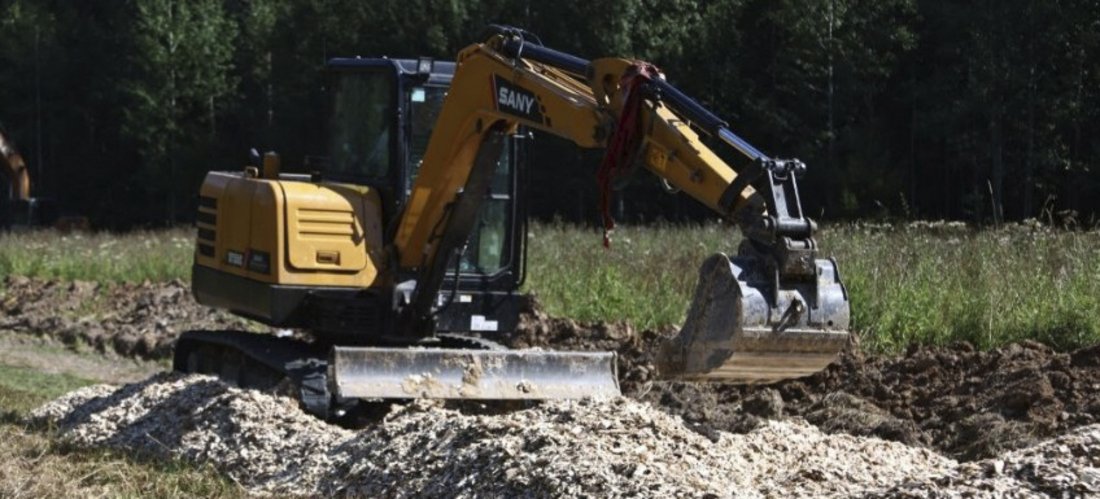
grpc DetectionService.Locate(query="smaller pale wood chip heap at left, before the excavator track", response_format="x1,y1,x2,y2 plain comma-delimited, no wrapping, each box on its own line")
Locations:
29,374,351,495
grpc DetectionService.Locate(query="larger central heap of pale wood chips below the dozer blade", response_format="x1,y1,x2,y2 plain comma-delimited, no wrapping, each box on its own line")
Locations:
334,398,955,497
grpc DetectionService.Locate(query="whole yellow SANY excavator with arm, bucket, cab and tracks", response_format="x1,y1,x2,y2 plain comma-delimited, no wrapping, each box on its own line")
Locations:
174,26,849,419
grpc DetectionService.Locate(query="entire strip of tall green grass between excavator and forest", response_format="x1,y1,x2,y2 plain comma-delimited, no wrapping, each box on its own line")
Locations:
0,223,1100,352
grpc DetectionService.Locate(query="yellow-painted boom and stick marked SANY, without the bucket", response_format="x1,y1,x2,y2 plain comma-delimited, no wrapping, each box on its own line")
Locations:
395,35,755,269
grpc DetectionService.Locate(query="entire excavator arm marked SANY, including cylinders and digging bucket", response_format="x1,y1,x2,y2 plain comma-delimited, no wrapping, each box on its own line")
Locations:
394,29,848,382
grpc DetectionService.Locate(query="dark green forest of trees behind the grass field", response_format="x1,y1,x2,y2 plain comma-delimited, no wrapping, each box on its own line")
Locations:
0,0,1100,229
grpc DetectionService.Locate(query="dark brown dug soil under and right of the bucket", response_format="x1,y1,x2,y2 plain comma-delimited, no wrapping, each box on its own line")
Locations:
512,312,1100,461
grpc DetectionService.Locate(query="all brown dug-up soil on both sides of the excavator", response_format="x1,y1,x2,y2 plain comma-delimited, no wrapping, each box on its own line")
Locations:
0,278,1100,468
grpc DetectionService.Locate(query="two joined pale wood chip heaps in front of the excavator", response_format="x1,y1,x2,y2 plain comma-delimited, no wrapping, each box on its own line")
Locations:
25,375,956,497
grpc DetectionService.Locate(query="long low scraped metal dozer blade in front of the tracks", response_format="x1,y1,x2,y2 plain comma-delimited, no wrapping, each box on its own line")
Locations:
329,346,619,400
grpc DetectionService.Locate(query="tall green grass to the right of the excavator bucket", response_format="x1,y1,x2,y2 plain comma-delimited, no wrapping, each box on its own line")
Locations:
823,225,1100,351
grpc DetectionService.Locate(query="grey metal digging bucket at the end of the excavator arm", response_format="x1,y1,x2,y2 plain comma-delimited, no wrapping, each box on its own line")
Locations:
657,254,849,384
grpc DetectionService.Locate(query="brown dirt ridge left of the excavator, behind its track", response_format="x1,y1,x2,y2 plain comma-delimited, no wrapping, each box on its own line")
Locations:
0,277,246,358
